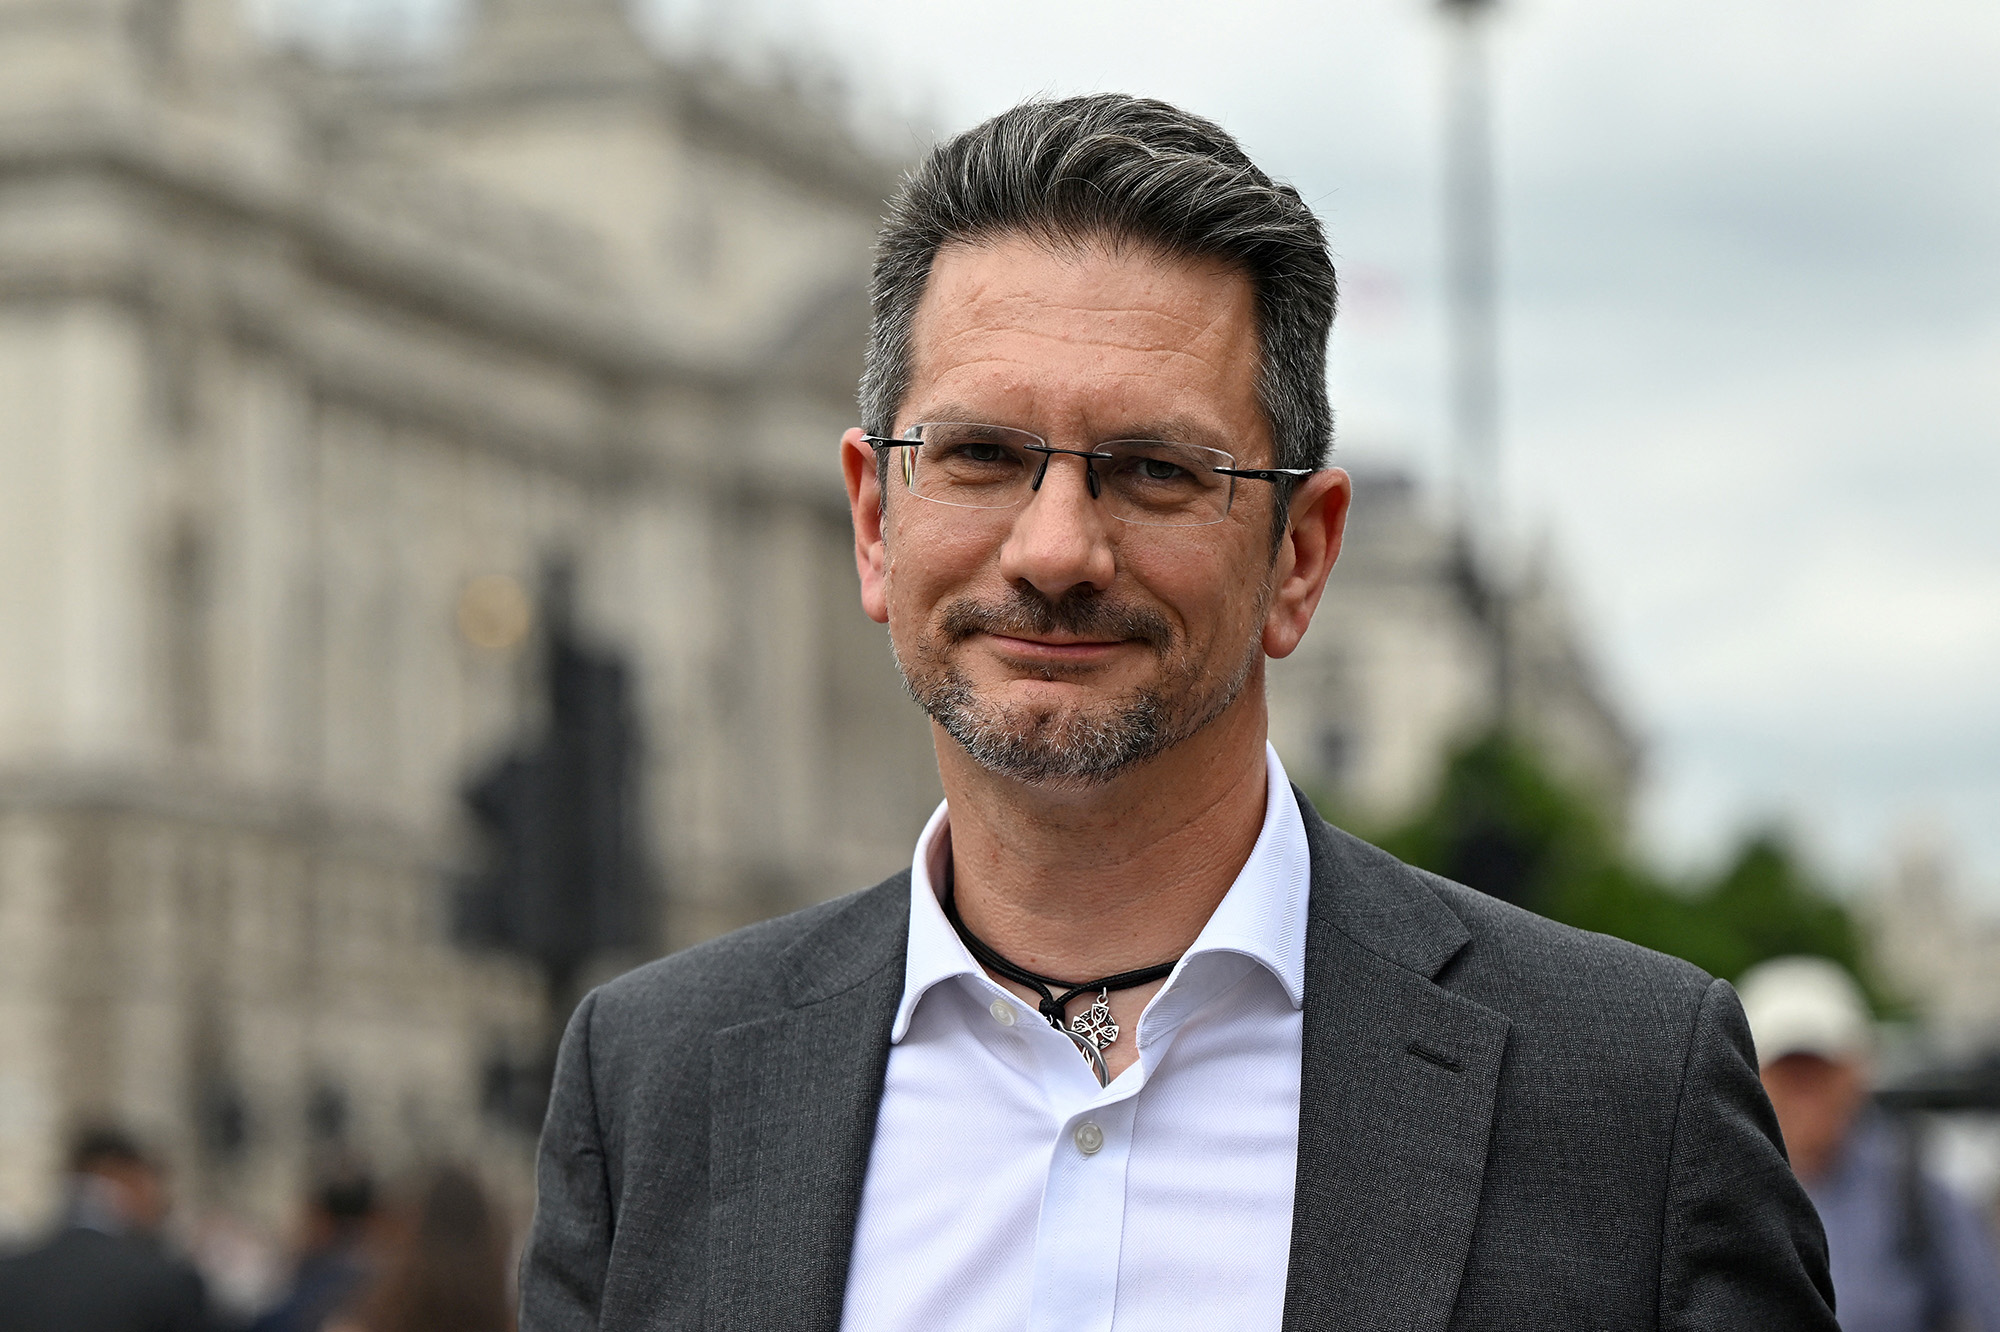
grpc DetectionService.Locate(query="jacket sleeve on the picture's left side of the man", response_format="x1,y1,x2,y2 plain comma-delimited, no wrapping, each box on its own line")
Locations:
520,994,616,1332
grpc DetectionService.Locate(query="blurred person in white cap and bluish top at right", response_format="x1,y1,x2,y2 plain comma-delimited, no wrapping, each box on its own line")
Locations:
1740,958,2000,1332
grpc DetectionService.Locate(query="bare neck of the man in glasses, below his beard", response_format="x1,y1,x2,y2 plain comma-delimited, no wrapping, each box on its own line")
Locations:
936,684,1268,978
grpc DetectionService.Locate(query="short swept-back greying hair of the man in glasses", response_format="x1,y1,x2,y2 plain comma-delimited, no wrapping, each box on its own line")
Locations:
860,92,1336,500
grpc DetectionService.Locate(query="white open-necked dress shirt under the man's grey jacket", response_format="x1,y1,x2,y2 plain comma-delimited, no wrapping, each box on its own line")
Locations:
842,746,1310,1332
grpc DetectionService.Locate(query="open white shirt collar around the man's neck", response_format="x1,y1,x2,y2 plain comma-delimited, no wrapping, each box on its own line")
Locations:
890,742,1312,1042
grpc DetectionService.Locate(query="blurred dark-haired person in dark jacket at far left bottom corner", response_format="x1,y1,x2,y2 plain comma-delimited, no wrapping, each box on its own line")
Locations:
0,1126,212,1332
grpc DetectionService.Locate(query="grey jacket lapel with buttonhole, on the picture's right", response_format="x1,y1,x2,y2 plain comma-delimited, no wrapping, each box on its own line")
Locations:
1284,798,1508,1332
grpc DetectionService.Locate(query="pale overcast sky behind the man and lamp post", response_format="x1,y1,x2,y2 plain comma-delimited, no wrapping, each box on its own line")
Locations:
274,0,2000,906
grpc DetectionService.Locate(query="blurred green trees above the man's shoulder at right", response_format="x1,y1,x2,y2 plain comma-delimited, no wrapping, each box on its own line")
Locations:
1372,730,1884,1008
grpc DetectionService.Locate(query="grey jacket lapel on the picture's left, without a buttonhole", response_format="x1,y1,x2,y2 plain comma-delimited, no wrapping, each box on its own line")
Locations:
708,874,910,1332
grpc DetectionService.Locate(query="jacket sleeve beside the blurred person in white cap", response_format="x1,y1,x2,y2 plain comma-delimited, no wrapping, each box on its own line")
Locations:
1660,980,1838,1332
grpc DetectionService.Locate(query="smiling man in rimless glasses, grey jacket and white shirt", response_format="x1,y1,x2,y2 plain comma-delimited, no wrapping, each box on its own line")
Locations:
522,96,1834,1332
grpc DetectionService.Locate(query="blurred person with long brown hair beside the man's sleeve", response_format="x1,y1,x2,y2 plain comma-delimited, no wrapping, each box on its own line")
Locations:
328,1166,514,1332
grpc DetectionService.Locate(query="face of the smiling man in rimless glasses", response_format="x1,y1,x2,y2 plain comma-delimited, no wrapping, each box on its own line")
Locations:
850,238,1310,784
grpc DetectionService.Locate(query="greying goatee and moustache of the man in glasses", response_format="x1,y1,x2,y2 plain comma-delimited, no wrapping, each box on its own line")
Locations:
892,590,1258,786
